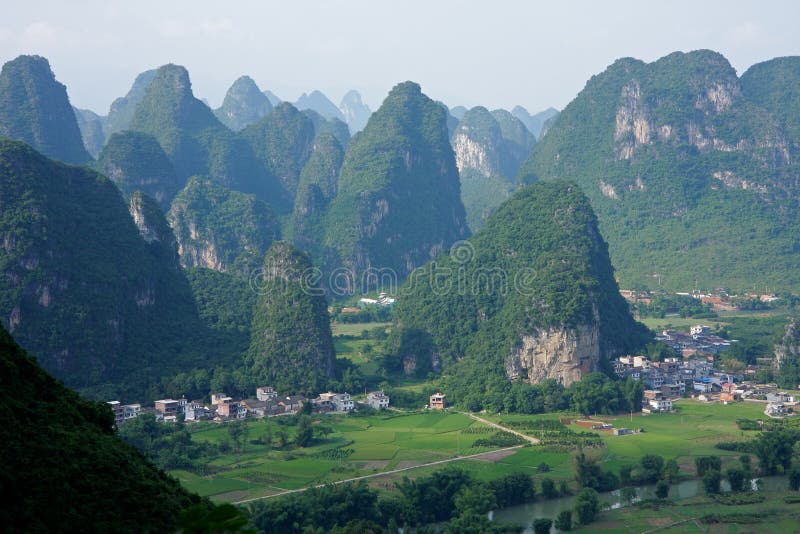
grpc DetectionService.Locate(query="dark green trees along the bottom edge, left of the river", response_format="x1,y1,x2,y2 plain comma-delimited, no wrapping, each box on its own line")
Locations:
250,467,600,534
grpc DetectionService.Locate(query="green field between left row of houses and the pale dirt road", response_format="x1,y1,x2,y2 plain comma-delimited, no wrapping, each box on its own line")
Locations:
172,412,495,501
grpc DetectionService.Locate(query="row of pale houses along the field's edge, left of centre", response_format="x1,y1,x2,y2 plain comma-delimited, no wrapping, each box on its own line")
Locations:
108,386,389,426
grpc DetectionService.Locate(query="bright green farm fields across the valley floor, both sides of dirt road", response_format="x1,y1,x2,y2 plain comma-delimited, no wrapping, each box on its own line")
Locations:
172,400,780,501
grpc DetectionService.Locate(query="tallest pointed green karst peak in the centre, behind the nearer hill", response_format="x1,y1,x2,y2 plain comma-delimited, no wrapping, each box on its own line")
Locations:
322,82,467,292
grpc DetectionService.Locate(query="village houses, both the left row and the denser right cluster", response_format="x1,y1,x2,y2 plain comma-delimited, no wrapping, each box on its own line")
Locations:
108,318,800,426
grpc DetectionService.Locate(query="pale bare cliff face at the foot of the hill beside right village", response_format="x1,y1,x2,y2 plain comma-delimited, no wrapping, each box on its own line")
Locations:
504,314,601,386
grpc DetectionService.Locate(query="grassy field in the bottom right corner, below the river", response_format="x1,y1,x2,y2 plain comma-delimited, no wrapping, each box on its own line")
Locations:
577,491,800,534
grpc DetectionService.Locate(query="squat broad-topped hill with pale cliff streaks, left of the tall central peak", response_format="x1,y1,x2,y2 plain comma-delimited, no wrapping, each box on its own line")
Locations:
167,176,280,279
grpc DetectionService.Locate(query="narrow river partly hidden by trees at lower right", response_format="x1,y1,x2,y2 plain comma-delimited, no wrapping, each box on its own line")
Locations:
489,477,788,534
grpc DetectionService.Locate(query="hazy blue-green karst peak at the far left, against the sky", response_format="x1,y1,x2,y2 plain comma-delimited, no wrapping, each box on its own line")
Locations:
0,56,92,163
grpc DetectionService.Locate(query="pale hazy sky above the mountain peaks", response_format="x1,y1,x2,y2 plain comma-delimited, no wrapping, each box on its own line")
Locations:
0,0,800,114
